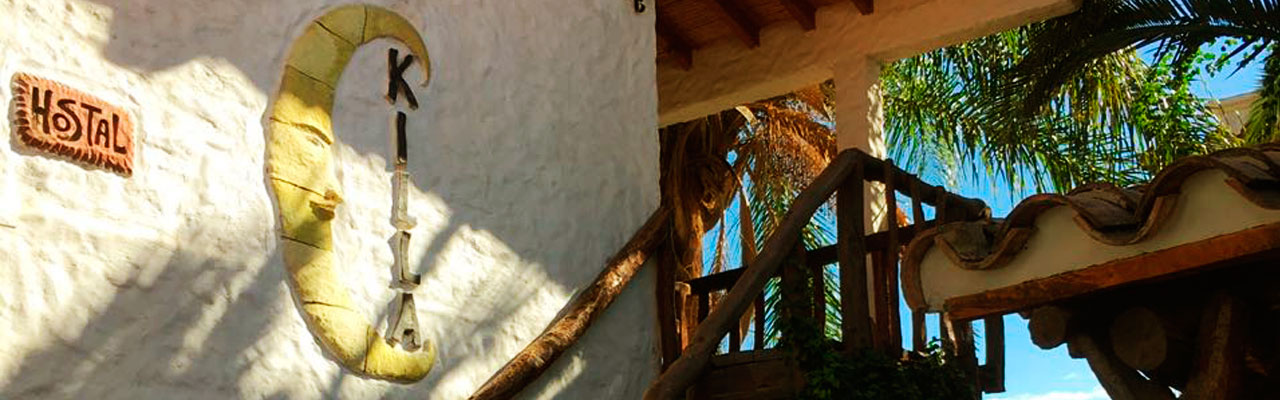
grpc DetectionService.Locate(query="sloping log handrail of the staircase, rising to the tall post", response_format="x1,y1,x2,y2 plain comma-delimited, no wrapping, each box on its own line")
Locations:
644,150,861,400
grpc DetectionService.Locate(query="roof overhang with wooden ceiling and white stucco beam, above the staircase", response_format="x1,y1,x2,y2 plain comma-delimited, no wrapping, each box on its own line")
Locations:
649,0,1082,128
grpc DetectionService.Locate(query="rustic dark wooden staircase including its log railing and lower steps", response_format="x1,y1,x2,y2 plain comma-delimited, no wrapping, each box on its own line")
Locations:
645,150,988,399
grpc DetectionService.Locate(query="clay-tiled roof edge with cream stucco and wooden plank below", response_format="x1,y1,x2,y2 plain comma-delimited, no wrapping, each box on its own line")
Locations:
902,145,1280,321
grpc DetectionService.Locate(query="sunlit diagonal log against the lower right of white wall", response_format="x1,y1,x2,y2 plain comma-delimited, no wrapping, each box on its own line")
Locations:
470,208,671,400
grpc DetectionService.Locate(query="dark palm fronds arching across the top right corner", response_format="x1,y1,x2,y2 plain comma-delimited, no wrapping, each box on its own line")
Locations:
991,0,1280,144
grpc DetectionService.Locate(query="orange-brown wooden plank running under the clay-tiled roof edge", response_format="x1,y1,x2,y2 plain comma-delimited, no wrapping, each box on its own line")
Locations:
946,223,1280,319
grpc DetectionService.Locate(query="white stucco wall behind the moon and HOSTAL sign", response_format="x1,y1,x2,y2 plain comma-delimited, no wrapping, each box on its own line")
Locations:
0,0,658,399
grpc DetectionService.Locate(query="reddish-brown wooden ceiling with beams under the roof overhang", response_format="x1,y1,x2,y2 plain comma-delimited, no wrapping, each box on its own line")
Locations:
655,0,876,69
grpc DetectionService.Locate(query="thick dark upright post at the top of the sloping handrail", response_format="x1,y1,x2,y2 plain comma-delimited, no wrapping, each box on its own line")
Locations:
836,163,872,353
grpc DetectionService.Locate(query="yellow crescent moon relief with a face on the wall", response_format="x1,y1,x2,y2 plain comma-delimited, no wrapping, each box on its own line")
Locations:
266,5,435,382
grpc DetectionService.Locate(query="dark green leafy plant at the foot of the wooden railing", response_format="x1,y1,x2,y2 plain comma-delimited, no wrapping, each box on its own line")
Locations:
778,265,975,400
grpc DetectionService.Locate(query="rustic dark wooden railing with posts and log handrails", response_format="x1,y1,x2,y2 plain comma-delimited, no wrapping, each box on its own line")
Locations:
645,150,988,400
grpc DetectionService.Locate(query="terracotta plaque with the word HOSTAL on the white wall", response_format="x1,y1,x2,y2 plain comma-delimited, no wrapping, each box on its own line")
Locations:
13,73,133,176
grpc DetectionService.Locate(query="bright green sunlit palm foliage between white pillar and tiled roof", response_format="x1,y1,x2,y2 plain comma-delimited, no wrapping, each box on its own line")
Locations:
882,22,1231,191
